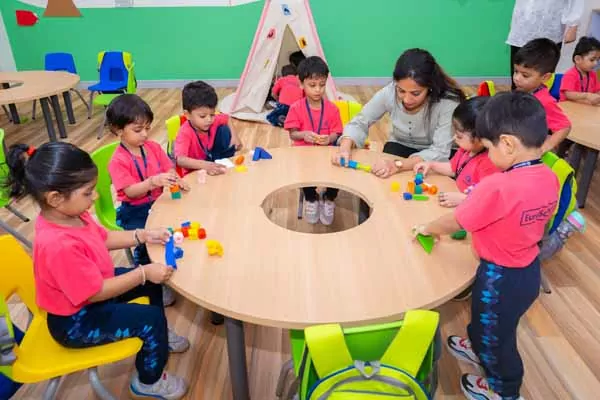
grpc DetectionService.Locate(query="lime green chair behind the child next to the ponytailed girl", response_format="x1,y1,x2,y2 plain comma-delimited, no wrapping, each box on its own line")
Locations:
92,142,134,265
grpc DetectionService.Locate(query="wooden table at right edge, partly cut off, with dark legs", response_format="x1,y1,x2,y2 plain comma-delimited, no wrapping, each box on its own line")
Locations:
558,101,600,208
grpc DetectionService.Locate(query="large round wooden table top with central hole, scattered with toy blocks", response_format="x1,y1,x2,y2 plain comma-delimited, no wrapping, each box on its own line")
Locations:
147,147,477,329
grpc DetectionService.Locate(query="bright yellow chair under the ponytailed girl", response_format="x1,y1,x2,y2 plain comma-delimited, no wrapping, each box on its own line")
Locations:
0,235,148,400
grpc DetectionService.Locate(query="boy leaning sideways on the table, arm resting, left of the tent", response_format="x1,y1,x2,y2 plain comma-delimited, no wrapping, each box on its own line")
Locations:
175,81,242,175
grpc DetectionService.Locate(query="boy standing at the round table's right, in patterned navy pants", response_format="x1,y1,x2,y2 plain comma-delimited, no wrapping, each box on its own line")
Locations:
414,92,559,400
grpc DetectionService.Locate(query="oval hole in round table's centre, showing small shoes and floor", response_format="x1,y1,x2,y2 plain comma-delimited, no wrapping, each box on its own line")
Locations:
261,184,371,234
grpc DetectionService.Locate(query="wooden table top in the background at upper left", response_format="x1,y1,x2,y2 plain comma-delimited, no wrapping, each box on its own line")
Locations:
0,71,79,105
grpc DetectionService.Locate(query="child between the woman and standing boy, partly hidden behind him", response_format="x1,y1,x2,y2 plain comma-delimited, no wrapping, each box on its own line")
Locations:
414,97,499,207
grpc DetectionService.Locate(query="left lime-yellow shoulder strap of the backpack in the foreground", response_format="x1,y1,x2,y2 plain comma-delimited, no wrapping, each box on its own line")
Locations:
304,324,354,378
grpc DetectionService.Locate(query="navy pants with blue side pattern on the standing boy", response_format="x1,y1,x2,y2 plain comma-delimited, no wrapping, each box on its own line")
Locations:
467,258,540,399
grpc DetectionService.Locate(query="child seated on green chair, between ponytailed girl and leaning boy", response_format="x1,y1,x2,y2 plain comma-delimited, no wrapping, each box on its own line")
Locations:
106,94,189,306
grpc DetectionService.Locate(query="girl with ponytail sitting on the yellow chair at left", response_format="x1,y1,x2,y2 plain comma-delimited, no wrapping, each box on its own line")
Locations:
7,142,189,399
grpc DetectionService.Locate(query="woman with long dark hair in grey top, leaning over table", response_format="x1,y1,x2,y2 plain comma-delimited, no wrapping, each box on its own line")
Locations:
333,49,465,178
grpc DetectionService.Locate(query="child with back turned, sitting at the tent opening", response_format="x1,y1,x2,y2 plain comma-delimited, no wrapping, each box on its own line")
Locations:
267,64,304,127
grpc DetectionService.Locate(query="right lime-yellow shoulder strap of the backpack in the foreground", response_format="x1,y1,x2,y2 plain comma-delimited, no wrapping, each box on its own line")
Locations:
381,310,440,377
